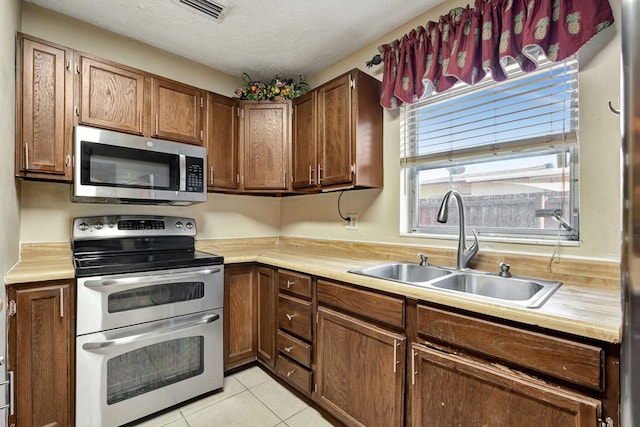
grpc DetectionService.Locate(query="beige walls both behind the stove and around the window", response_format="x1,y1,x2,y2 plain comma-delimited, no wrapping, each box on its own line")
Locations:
20,0,621,260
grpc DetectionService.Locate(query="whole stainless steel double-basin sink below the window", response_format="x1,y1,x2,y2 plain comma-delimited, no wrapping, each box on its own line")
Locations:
349,262,562,308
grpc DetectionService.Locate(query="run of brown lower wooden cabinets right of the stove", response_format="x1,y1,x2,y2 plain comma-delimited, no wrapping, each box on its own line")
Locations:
225,265,620,427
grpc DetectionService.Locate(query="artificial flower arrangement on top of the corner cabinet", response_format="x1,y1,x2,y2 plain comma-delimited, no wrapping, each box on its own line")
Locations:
235,73,309,102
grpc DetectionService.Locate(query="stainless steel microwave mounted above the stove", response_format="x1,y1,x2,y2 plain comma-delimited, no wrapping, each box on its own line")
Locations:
72,126,207,205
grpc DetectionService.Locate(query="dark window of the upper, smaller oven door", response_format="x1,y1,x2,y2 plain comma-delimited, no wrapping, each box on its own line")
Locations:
107,282,204,313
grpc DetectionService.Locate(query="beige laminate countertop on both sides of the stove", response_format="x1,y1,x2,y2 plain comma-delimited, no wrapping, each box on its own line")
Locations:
5,241,622,343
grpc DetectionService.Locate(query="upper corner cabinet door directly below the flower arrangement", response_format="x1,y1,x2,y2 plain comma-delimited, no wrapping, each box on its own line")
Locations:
241,101,289,191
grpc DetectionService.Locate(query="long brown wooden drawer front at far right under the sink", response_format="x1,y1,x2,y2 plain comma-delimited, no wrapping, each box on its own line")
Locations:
418,305,604,390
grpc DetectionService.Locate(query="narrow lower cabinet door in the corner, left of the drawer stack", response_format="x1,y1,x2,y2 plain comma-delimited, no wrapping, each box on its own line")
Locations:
256,267,277,368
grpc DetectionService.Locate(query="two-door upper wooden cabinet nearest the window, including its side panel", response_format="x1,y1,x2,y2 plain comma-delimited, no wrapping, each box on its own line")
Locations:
292,69,383,190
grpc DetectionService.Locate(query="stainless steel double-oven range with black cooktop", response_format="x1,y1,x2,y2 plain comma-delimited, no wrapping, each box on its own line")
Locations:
73,216,224,427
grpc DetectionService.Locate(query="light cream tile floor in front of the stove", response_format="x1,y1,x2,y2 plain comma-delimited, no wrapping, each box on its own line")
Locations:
131,366,340,427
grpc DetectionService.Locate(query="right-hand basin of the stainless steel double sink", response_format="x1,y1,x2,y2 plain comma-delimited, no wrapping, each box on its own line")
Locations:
430,272,561,308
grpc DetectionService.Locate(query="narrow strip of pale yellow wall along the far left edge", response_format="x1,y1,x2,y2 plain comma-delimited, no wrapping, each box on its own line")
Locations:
0,0,20,274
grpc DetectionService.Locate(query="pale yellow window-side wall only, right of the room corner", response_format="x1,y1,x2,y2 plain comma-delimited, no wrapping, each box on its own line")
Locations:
280,0,621,260
